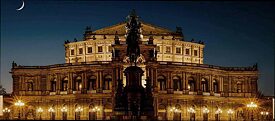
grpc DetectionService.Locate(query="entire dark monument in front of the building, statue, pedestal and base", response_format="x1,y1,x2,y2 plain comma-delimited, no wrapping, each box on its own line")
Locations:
114,10,154,120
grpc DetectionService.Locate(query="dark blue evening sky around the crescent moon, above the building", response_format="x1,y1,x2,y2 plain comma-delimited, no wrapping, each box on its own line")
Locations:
1,0,275,95
